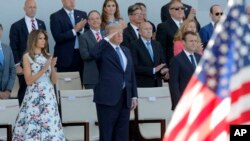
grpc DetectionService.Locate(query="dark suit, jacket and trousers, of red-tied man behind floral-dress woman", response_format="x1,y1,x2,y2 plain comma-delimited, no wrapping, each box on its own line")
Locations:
9,18,46,105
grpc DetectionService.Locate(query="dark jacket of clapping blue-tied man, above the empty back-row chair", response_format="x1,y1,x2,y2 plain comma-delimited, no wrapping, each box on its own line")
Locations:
50,8,87,67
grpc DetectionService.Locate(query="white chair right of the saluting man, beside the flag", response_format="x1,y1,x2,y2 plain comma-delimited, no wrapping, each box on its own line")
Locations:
137,87,172,140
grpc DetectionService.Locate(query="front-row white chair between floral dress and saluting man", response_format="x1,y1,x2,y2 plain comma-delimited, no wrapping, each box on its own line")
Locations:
60,89,99,141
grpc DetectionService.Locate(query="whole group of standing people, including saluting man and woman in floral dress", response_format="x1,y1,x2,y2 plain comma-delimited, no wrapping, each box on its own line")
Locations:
0,0,250,141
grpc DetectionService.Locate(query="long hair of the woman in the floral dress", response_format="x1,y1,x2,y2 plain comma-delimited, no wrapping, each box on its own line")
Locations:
26,30,50,61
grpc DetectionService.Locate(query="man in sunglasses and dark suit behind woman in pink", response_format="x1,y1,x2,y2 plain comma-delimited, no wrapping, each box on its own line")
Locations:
156,1,184,65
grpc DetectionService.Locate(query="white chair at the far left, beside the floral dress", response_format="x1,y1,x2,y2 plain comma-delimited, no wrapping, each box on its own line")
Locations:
0,99,19,141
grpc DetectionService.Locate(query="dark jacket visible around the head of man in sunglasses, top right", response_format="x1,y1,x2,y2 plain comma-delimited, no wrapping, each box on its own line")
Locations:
161,2,201,31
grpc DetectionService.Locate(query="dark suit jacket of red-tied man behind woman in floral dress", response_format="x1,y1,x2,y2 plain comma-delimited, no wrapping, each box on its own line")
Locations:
9,18,46,63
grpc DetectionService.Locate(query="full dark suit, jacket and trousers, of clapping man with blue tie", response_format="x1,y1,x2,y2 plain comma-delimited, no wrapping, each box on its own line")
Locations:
50,8,87,83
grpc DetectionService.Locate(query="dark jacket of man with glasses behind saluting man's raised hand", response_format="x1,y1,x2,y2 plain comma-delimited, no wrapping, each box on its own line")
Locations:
121,23,138,48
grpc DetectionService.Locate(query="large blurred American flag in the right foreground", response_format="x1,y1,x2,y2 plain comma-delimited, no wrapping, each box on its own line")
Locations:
163,0,250,141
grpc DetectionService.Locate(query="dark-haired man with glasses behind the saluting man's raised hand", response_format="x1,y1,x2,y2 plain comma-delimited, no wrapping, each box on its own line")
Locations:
122,4,144,48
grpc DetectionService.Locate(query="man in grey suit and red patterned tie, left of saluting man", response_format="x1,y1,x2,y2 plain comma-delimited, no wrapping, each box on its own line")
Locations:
79,10,103,89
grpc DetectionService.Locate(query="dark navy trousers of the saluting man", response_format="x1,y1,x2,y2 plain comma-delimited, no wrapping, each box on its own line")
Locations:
96,90,130,141
